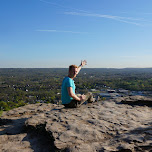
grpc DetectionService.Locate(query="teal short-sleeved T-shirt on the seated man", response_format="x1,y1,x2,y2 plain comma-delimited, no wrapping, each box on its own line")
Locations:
61,77,75,104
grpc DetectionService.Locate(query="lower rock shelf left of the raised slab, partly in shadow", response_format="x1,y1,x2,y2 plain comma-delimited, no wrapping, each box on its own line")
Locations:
0,104,57,152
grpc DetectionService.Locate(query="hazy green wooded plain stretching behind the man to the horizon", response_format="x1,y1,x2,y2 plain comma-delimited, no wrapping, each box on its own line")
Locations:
0,68,152,110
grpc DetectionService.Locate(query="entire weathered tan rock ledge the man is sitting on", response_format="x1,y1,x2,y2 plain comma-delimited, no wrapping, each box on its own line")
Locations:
0,96,152,152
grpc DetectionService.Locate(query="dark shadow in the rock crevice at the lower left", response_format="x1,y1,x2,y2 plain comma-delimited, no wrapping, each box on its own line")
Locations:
0,118,55,152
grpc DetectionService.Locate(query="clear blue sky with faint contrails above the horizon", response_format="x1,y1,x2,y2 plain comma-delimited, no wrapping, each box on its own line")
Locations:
0,0,152,68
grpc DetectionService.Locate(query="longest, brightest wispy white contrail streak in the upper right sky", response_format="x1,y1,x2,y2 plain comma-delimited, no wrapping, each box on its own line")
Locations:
65,12,143,26
